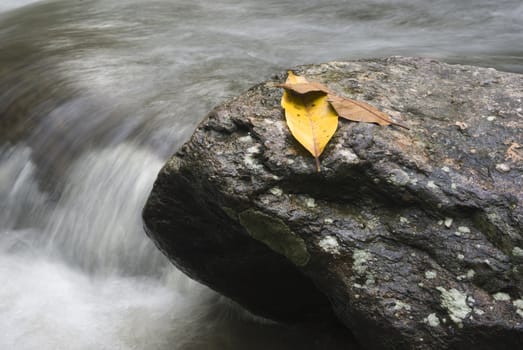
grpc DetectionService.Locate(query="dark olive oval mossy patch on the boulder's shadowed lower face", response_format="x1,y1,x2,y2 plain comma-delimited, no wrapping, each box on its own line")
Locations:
239,209,310,266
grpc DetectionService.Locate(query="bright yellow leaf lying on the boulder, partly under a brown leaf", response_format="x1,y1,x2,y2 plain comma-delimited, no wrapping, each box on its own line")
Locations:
281,72,338,171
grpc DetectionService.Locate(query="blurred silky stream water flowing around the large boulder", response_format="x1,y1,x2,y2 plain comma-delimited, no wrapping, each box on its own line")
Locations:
0,0,523,350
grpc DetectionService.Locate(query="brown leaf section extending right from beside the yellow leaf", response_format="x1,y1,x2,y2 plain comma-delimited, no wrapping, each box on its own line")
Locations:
328,94,408,129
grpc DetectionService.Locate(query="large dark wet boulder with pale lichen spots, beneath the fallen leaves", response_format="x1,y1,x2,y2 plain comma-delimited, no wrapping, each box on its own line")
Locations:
143,57,523,349
